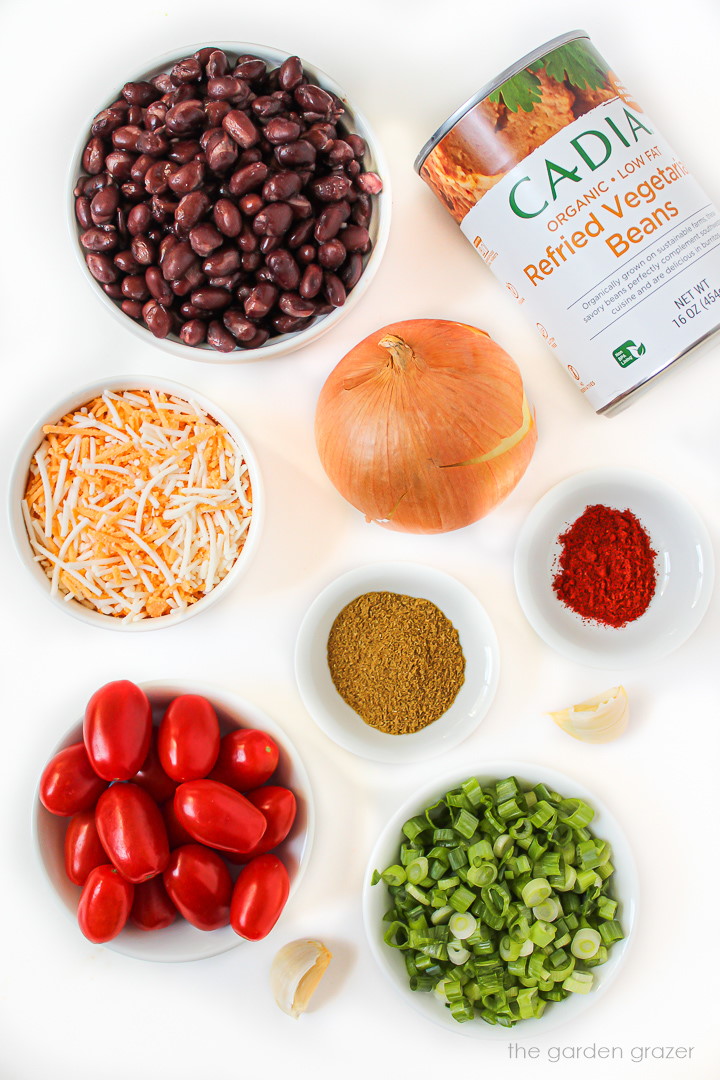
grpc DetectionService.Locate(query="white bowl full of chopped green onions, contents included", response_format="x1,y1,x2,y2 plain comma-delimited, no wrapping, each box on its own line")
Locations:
363,761,638,1039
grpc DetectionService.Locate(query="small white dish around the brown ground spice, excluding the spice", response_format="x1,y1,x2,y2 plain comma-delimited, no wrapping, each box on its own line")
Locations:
295,563,500,764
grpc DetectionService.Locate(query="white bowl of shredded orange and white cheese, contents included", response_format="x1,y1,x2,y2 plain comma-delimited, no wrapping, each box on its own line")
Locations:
10,376,262,631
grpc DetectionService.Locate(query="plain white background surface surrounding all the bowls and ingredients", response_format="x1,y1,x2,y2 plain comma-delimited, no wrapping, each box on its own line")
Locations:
0,0,720,1080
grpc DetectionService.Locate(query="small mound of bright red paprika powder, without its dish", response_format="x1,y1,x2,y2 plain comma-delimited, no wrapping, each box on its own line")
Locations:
553,505,656,627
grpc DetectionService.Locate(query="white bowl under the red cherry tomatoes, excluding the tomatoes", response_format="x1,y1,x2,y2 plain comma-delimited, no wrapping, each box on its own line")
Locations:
32,680,315,962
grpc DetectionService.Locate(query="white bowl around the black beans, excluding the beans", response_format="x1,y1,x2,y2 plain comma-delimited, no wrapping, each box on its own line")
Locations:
67,41,392,364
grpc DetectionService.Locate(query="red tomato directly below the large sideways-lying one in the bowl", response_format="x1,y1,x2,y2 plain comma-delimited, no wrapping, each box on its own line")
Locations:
163,843,232,930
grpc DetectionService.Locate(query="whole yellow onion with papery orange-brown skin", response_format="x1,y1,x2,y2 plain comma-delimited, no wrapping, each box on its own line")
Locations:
315,319,538,532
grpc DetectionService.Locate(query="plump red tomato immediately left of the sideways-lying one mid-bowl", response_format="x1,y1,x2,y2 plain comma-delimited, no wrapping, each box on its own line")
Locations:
95,784,169,883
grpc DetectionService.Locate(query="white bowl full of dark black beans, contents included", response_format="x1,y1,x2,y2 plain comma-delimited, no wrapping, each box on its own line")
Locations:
70,43,391,363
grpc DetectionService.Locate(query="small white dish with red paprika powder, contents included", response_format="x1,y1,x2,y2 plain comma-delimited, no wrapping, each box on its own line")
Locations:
515,469,715,670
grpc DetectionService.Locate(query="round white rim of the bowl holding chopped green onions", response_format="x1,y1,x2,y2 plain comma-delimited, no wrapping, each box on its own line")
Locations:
363,758,640,1040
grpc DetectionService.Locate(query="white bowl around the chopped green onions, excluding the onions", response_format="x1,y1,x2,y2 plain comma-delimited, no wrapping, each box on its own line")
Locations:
363,760,639,1041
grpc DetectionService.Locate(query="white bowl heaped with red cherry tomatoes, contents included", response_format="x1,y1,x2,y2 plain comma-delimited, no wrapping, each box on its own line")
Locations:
33,679,314,961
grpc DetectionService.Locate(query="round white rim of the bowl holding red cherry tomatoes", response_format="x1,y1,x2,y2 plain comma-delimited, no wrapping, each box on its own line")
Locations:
31,678,315,963
